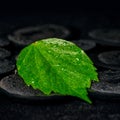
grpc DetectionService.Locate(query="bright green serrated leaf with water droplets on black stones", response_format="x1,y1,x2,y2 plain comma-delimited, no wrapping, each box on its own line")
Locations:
17,38,98,103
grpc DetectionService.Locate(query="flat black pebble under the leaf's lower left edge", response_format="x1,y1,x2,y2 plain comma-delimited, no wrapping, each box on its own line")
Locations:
0,74,63,100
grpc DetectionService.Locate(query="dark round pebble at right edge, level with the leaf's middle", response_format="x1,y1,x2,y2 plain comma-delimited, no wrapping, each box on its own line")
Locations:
90,50,120,70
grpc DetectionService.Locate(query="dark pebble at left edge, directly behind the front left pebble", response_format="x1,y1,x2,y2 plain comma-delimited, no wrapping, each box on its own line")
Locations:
0,59,15,75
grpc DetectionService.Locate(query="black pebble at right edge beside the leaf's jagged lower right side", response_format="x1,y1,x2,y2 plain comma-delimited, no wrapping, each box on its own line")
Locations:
91,70,120,99
